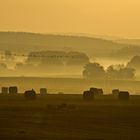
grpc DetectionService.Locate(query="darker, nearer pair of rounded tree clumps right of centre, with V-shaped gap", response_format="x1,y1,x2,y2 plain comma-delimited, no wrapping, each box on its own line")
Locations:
83,63,135,80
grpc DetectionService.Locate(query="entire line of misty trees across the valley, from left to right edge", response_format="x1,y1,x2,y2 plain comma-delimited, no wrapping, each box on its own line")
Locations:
0,51,140,80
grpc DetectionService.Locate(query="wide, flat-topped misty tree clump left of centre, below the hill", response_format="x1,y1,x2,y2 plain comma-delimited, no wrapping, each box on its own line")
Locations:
26,51,89,67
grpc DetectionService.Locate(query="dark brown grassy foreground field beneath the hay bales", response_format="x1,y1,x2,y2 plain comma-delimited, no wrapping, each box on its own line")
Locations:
0,94,140,140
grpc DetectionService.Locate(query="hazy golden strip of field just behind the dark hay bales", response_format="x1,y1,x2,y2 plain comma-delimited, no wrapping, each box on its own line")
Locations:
0,77,140,94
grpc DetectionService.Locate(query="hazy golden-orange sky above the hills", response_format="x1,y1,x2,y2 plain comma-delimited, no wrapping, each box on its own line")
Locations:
0,0,140,38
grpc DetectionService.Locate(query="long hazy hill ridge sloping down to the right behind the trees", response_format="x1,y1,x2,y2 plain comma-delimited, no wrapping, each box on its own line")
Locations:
0,32,133,57
